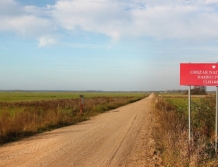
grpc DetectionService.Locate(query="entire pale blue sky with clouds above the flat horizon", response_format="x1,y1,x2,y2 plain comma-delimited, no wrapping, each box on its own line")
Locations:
0,0,218,91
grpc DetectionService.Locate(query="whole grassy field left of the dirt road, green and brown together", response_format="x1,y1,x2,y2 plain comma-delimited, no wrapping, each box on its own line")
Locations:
0,92,148,145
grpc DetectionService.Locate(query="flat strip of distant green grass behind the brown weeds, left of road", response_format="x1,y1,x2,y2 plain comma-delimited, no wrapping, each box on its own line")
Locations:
0,92,146,102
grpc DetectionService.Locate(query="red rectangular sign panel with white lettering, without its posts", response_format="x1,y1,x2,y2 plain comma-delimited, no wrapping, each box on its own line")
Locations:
180,63,218,86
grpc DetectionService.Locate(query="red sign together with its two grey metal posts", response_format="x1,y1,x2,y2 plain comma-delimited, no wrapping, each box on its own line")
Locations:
180,63,218,153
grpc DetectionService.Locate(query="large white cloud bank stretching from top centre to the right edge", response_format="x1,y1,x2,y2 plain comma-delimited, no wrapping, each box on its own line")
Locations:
50,0,218,40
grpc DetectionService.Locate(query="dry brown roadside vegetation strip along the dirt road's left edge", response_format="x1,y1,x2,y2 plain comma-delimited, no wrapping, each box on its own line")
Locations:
0,96,145,144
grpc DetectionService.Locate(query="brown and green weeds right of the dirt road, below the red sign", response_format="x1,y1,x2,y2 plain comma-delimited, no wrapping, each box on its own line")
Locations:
154,95,218,167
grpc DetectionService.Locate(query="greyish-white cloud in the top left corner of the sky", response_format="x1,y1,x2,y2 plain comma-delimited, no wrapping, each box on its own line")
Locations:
0,0,53,38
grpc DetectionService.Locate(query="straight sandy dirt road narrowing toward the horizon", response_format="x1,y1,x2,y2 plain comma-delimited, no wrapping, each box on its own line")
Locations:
0,95,157,167
